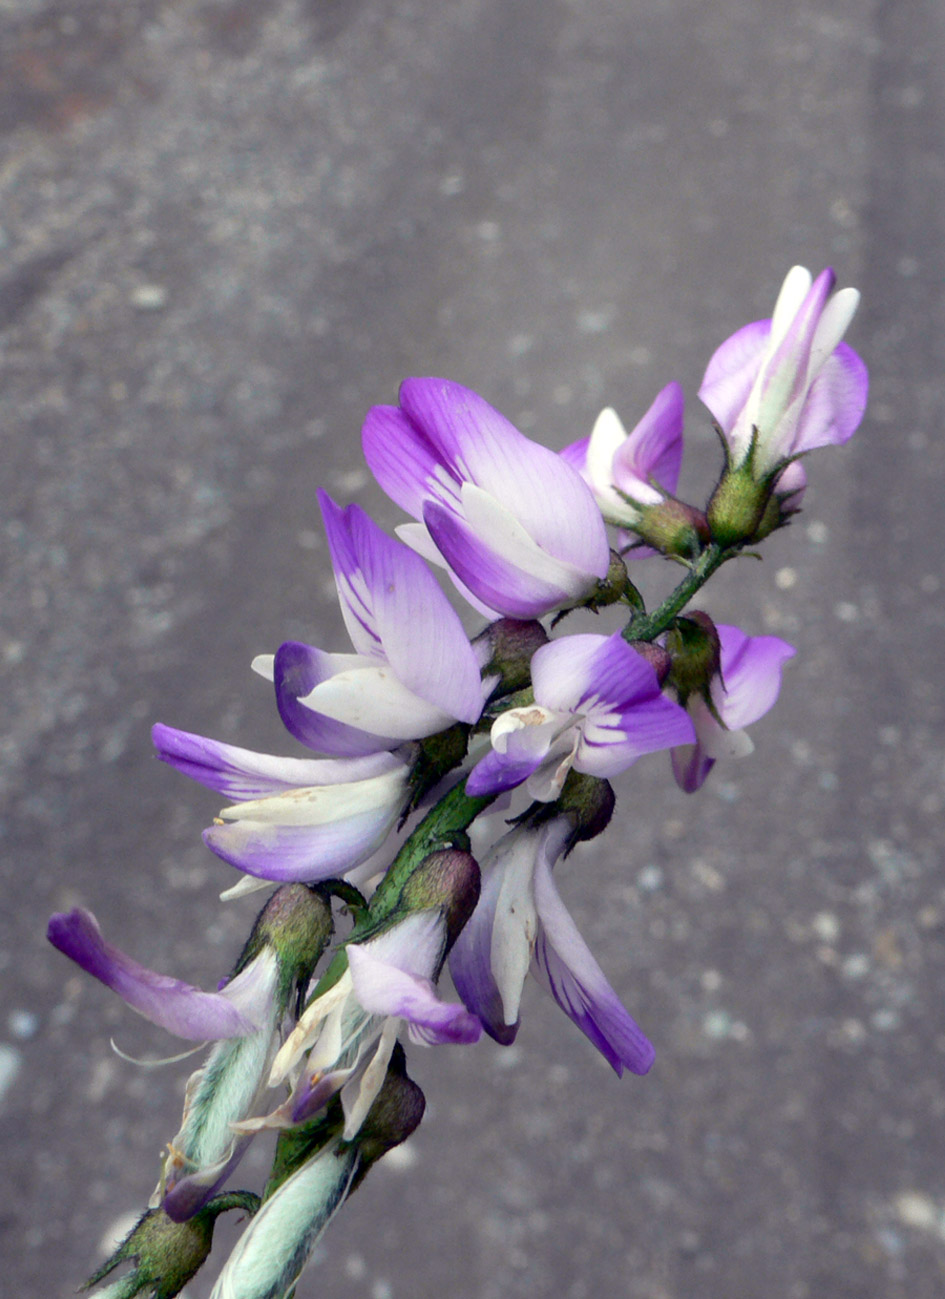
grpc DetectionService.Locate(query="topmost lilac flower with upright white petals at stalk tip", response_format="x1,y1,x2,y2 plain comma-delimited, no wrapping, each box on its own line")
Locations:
699,266,867,481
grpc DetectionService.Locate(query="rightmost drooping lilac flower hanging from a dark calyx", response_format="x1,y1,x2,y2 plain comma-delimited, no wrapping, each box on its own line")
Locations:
672,622,796,794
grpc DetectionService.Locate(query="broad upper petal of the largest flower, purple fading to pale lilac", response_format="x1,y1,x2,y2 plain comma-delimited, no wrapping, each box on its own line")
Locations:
400,379,610,578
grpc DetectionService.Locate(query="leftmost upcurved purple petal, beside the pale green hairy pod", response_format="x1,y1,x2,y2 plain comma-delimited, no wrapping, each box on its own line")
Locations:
47,907,278,1042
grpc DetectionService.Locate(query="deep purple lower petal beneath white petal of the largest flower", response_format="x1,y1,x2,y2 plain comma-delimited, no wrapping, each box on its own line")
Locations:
424,501,587,618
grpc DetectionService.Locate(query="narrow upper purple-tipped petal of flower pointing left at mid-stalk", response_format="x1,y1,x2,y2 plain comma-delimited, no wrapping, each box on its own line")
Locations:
151,722,402,801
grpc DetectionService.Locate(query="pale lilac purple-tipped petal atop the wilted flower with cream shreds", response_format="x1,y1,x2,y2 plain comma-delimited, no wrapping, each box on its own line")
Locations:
346,943,482,1043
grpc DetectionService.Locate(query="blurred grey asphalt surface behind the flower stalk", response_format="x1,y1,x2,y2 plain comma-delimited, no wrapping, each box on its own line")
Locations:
0,0,945,1299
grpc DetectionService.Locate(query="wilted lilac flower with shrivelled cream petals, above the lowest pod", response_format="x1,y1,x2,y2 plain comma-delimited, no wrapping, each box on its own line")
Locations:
269,908,482,1141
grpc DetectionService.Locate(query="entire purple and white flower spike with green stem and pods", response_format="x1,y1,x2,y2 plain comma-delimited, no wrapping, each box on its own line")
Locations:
48,268,866,1299
